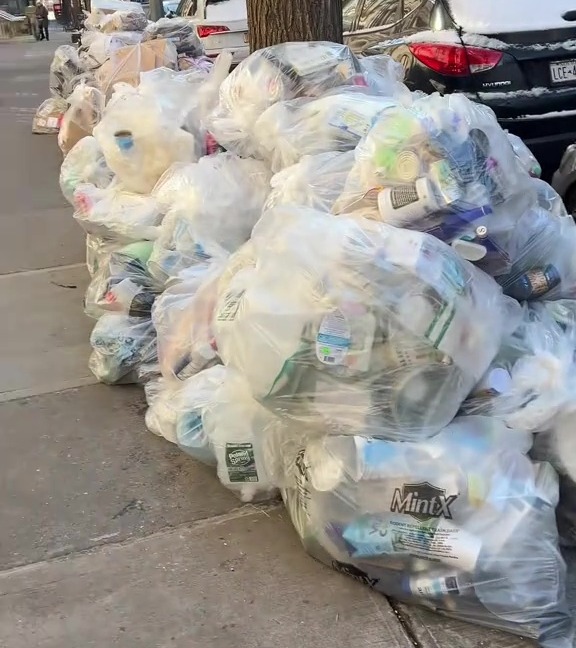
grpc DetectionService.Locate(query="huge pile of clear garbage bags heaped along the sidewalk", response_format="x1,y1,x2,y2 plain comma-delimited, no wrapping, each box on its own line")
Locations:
49,30,576,648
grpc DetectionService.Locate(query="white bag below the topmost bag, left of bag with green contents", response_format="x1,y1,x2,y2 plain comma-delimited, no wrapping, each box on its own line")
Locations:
254,88,395,171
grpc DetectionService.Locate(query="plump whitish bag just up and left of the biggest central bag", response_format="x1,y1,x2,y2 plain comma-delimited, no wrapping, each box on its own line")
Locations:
149,153,270,280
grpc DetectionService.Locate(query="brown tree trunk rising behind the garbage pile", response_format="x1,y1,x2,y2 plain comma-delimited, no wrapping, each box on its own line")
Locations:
248,0,343,52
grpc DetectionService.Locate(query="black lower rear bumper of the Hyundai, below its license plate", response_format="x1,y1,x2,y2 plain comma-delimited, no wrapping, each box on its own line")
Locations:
498,113,576,180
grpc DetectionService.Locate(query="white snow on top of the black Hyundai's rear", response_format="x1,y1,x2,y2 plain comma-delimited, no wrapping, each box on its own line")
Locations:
448,0,576,34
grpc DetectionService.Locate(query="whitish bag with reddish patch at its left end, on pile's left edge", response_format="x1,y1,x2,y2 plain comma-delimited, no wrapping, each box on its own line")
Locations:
74,184,162,243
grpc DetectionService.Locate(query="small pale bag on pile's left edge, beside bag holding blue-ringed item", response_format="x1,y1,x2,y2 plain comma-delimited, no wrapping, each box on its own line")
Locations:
60,136,114,205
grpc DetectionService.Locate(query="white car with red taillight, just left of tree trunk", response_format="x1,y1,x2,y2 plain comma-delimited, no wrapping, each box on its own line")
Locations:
177,0,250,64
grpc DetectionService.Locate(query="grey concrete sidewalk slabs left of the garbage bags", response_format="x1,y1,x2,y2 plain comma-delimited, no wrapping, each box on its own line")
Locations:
0,32,564,648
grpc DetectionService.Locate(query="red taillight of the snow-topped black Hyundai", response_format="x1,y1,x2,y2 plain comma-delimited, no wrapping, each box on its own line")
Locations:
408,43,502,76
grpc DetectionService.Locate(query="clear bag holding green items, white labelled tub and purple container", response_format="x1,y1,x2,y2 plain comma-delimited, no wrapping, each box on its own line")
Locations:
339,94,536,276
